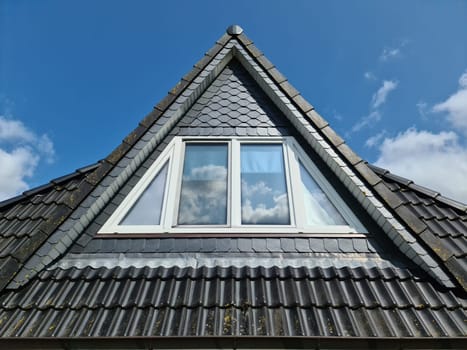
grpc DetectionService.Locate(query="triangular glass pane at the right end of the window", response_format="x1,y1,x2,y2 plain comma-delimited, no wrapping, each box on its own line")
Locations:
300,163,347,225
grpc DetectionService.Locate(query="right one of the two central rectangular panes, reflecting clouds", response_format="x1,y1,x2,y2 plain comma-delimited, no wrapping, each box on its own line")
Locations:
240,144,290,225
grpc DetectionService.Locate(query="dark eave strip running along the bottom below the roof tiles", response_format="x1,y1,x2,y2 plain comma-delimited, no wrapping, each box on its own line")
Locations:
0,335,467,349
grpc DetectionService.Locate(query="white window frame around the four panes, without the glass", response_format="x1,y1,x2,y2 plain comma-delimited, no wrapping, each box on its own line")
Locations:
98,136,367,234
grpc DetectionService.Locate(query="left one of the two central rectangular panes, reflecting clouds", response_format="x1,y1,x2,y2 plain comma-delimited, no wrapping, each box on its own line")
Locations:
178,143,228,225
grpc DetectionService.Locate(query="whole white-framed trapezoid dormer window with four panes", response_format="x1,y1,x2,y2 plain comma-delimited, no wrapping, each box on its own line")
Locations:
100,137,365,233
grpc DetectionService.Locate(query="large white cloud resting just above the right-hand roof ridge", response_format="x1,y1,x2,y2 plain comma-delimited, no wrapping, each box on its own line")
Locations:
375,128,467,203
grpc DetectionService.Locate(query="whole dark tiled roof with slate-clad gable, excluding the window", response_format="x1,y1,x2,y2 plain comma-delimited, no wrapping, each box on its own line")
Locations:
0,27,467,346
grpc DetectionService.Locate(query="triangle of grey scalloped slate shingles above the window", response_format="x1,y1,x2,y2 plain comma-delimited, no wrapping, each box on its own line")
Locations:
176,59,292,137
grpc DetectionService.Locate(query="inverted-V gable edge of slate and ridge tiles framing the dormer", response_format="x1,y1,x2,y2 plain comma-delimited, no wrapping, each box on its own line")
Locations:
6,25,456,287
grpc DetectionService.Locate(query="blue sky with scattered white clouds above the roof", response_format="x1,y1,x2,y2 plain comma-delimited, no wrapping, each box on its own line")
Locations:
0,0,467,202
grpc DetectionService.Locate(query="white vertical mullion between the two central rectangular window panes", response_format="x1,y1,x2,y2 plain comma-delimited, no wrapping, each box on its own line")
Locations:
229,139,242,227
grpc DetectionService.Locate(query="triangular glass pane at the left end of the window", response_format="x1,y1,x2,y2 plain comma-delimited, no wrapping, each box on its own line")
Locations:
120,162,168,225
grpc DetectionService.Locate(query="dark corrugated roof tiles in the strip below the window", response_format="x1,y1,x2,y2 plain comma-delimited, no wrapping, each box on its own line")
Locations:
0,267,467,337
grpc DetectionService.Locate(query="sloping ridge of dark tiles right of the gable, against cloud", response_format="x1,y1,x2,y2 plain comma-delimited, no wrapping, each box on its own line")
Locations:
367,163,467,213
